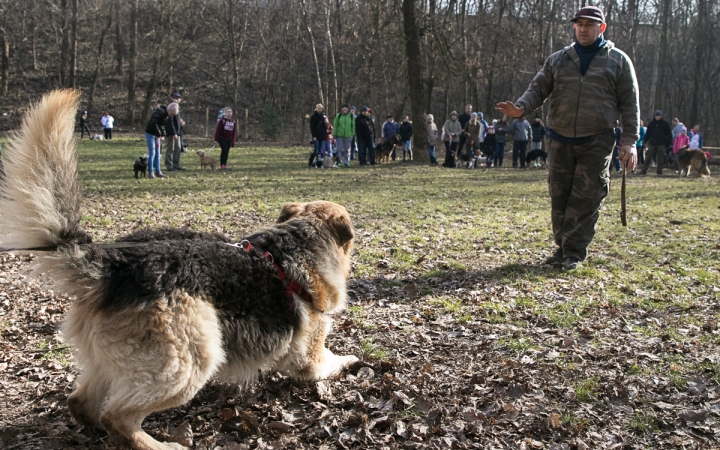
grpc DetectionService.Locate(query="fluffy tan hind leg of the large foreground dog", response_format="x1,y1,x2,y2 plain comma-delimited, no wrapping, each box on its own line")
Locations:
71,293,225,450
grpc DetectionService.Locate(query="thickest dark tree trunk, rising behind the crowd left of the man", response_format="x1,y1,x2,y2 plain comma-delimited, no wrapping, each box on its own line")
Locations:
402,0,429,163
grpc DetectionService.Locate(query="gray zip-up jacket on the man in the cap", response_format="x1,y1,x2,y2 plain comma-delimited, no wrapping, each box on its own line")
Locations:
515,41,640,142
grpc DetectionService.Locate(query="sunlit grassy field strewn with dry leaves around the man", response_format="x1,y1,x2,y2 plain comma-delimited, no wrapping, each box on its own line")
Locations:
0,138,720,448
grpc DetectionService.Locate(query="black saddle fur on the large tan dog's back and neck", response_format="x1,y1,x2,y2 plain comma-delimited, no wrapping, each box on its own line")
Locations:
79,219,332,339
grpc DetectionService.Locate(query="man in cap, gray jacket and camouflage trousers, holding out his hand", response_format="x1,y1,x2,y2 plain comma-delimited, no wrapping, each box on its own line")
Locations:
496,6,640,270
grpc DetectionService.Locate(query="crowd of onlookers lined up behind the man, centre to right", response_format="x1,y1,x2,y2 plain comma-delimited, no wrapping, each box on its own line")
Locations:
308,104,712,175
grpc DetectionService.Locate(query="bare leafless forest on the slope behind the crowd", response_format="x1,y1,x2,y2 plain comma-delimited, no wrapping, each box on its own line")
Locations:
0,0,720,145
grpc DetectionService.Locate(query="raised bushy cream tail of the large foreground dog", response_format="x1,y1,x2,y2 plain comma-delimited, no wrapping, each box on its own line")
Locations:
0,90,91,249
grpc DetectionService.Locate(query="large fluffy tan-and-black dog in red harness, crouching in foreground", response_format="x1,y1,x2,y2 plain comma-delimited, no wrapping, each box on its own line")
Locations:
0,90,357,449
